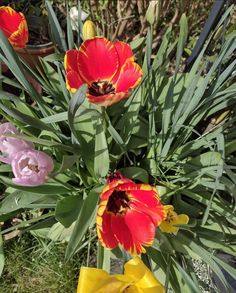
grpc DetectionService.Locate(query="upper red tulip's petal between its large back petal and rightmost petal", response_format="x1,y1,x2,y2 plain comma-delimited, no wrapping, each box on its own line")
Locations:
112,42,134,83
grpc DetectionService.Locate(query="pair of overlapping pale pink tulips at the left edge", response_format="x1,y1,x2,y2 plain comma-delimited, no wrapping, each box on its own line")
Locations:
0,123,53,186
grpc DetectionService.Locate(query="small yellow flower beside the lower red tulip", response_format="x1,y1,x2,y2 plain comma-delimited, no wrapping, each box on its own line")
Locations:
159,205,189,234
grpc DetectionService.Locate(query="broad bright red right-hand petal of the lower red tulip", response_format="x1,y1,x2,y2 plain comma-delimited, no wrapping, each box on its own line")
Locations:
124,210,155,253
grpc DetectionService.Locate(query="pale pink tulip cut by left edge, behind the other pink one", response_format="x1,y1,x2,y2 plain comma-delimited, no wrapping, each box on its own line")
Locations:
0,122,34,164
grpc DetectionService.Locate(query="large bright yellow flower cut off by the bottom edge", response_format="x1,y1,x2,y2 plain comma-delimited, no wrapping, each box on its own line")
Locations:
77,257,165,293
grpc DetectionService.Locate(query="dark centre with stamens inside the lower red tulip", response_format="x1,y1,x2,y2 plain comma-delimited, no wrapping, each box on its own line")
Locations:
107,190,130,215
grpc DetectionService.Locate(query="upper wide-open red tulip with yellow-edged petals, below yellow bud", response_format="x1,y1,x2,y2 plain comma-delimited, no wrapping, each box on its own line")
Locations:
65,37,143,106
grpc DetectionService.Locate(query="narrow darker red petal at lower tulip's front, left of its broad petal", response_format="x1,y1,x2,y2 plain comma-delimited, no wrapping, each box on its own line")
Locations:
111,214,137,254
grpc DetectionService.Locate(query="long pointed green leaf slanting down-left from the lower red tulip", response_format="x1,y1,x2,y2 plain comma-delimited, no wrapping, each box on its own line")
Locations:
65,188,102,261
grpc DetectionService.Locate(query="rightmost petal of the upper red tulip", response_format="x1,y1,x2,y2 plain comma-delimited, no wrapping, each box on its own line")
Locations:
116,61,143,93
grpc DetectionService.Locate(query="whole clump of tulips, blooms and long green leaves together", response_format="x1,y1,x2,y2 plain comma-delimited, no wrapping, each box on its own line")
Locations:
0,1,236,293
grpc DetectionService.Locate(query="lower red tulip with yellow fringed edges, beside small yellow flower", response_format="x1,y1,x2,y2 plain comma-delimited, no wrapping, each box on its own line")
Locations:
96,171,164,254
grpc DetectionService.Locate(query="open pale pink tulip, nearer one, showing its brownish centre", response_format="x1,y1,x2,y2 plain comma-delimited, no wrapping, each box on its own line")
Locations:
11,149,53,186
